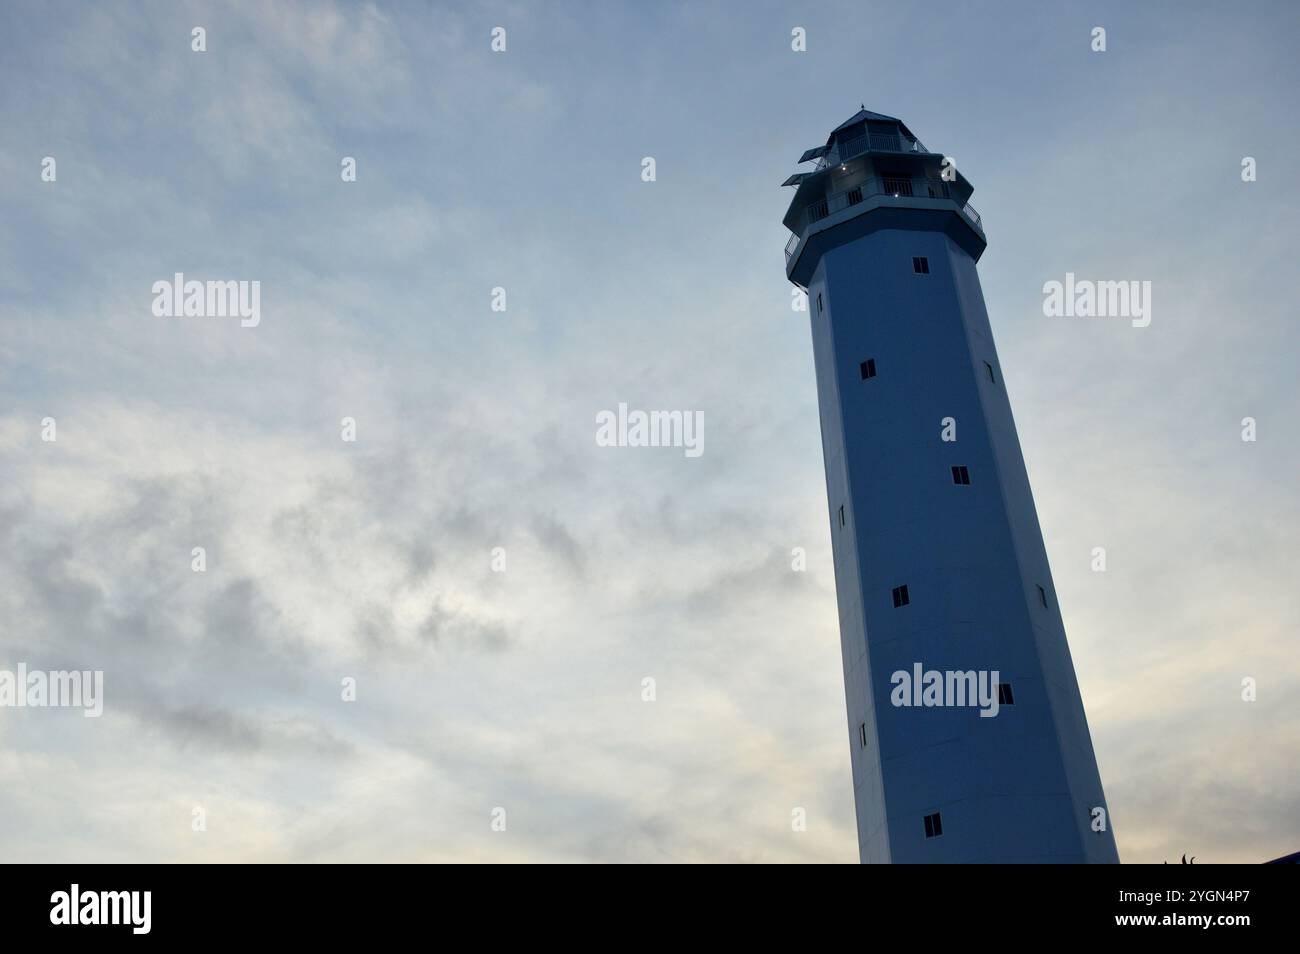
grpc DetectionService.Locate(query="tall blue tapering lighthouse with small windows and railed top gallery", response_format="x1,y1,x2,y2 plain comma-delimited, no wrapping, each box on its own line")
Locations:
783,109,1119,863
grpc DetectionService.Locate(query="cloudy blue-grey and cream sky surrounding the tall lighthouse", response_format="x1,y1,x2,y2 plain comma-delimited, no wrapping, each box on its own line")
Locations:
0,0,1300,863
